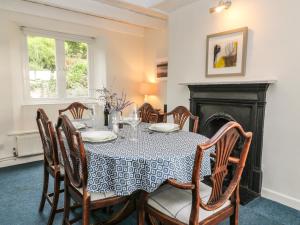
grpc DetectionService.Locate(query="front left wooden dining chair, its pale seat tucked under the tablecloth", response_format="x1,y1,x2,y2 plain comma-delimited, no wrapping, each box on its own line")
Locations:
56,115,128,225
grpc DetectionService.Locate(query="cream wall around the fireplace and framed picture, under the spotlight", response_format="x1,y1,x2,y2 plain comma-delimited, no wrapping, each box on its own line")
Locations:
167,0,300,209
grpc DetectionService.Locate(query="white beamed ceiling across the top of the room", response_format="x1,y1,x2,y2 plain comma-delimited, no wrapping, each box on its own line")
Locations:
18,0,199,29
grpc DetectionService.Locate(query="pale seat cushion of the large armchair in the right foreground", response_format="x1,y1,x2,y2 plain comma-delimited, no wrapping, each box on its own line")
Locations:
148,183,230,224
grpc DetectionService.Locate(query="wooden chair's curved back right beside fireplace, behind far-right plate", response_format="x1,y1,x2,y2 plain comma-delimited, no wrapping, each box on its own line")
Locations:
164,106,199,133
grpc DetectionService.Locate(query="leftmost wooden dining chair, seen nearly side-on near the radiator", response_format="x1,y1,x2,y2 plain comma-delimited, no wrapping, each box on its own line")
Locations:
36,109,64,225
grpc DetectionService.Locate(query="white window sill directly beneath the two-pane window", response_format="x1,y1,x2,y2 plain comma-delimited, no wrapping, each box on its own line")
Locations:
21,98,98,107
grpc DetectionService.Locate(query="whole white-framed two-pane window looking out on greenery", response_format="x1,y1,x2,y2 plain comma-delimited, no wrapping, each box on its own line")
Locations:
24,28,92,101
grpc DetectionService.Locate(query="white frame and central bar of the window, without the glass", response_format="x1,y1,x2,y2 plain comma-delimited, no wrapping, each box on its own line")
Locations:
21,27,95,105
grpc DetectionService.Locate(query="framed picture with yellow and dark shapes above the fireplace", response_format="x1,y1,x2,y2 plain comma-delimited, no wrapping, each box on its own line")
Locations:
206,27,248,77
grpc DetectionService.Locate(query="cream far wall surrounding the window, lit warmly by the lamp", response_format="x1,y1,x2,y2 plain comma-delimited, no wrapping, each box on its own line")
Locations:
0,10,144,159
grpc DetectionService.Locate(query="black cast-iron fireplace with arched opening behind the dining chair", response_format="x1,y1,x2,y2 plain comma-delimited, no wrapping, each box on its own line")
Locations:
187,82,270,204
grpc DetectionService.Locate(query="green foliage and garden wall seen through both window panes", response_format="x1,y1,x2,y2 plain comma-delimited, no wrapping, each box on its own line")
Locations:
27,36,88,97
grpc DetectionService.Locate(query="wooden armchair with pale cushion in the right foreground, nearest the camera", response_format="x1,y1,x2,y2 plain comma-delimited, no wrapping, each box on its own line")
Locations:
145,122,252,225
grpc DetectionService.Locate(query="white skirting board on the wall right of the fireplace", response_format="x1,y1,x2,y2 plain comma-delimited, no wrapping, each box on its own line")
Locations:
261,188,300,210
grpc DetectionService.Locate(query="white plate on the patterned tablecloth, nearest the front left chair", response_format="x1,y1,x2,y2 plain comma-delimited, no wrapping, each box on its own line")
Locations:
81,131,117,142
